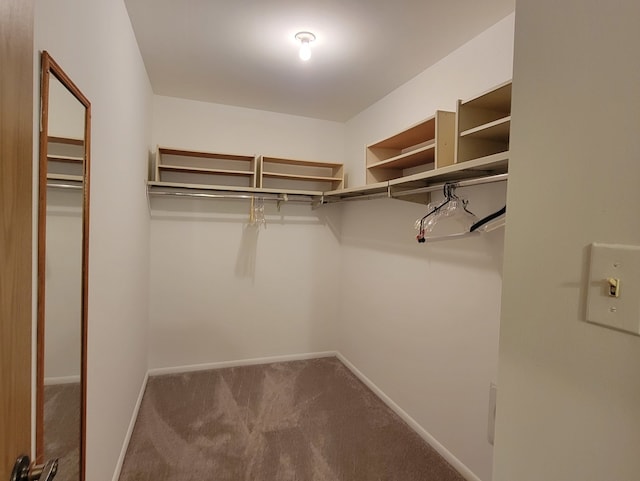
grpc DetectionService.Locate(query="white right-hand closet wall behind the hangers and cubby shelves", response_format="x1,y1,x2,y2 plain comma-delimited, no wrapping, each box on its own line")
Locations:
337,15,514,480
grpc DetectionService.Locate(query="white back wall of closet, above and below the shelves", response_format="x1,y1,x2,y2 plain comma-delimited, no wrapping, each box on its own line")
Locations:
149,96,344,368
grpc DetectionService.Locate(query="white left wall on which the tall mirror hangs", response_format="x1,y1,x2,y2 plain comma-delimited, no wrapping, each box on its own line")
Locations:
35,0,151,481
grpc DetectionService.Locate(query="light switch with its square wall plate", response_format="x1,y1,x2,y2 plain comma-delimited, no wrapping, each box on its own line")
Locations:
587,243,640,335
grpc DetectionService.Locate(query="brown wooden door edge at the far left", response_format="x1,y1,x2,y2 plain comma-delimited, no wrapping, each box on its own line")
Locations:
0,0,34,481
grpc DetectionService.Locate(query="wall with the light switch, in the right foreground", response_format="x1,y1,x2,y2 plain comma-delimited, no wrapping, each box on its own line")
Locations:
494,0,640,481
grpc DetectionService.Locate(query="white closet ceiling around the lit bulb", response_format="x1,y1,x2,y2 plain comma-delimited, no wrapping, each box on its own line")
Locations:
125,0,515,121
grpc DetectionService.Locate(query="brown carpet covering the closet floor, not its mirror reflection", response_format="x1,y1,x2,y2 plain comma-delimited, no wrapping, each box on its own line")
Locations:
120,358,463,481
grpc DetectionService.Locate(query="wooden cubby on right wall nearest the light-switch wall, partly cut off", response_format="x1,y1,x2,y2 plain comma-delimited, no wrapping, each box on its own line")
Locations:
455,81,511,163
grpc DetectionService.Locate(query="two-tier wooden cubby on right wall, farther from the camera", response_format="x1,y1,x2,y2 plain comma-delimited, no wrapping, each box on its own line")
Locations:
366,110,455,184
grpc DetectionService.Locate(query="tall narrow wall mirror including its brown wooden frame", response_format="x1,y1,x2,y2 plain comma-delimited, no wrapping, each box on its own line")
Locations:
36,52,91,481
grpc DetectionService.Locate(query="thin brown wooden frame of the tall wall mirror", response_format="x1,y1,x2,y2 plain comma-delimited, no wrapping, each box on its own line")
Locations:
36,51,91,481
